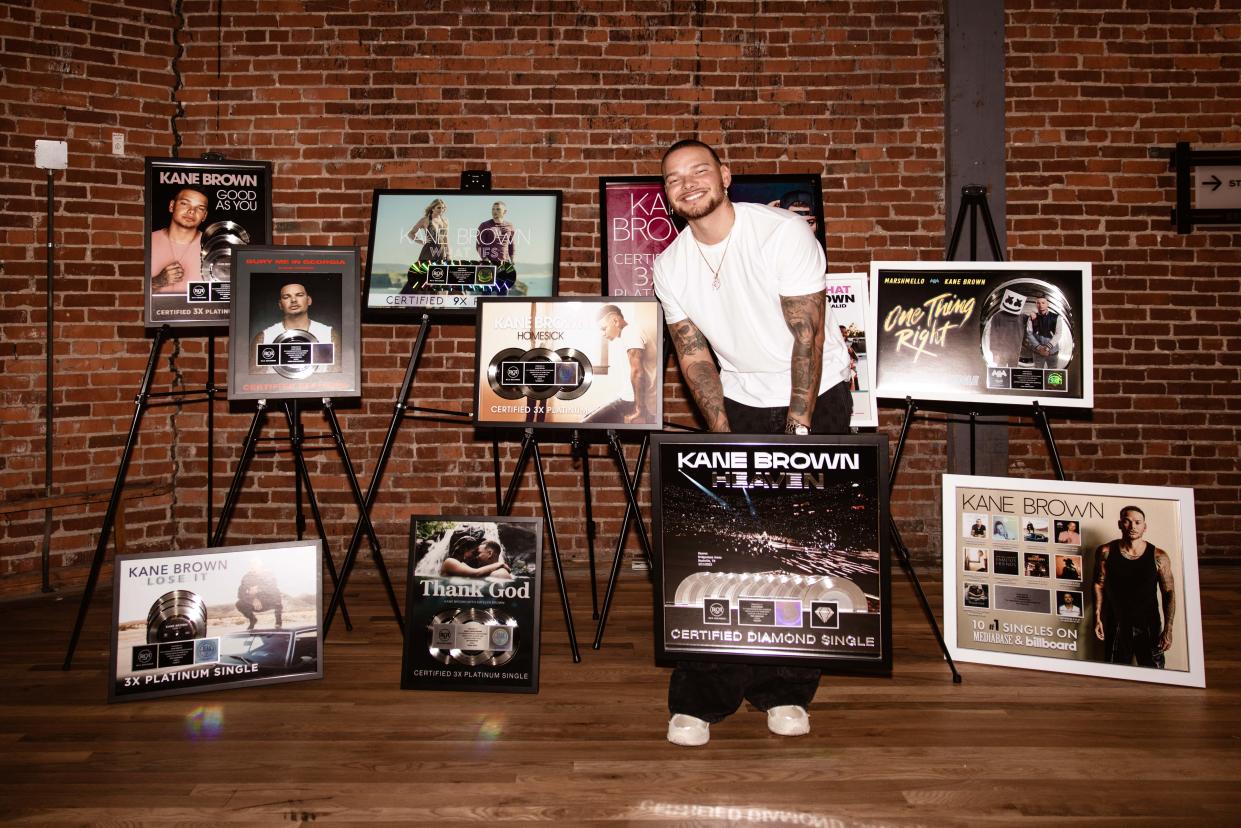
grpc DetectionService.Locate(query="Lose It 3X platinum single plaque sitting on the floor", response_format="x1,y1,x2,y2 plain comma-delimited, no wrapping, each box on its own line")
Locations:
108,541,323,701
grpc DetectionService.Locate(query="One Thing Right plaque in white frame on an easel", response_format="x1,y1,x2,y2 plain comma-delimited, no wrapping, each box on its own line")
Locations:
870,262,1095,408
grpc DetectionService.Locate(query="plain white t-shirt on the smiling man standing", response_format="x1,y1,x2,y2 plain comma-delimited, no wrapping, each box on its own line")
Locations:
654,204,849,408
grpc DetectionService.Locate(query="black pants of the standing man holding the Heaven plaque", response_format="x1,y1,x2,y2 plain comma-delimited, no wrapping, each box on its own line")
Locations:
668,382,853,724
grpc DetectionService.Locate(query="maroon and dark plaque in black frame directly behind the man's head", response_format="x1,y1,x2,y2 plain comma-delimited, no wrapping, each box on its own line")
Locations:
599,173,828,298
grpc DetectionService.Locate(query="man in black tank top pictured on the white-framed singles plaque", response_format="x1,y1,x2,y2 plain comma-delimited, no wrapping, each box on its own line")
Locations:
1095,506,1176,669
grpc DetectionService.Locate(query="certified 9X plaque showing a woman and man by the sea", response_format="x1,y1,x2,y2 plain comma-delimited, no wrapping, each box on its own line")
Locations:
364,190,561,323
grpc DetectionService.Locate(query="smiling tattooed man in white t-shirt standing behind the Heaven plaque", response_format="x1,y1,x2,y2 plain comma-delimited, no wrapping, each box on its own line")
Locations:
654,140,853,745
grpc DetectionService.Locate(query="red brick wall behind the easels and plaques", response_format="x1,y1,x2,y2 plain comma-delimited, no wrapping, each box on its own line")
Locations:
0,0,1241,593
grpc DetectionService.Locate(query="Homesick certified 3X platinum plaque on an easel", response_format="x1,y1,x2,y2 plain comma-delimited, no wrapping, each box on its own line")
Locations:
474,297,664,430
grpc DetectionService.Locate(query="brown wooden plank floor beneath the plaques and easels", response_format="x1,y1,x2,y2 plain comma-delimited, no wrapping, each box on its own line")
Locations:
0,565,1241,828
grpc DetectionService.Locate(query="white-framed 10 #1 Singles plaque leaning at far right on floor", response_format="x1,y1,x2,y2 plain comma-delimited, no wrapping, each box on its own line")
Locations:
943,474,1205,686
